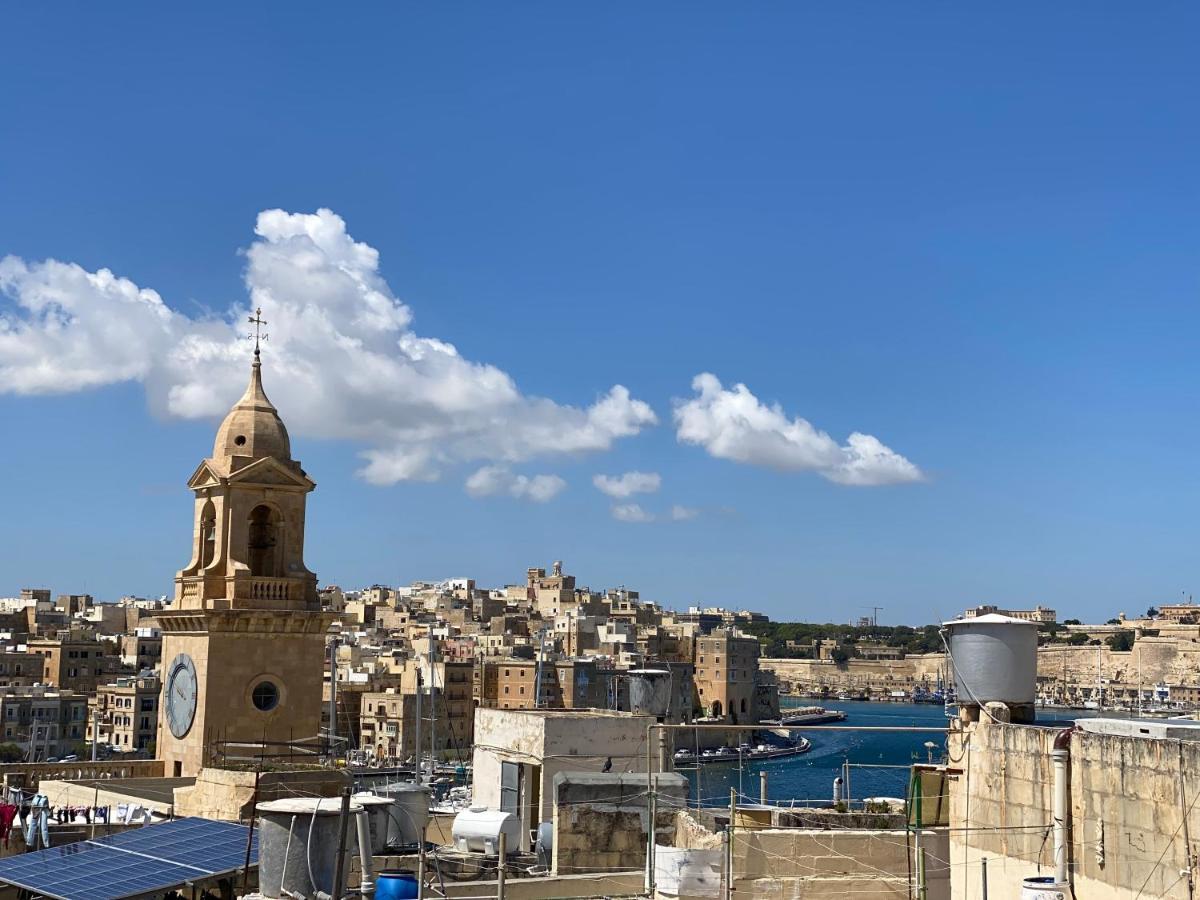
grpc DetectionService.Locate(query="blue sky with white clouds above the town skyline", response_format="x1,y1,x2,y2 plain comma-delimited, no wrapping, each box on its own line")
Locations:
0,4,1200,622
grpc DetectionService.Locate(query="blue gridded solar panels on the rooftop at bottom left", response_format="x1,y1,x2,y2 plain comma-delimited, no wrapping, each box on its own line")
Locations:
0,818,258,900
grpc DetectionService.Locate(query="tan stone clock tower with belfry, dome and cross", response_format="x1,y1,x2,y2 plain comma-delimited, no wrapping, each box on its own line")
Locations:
158,316,336,776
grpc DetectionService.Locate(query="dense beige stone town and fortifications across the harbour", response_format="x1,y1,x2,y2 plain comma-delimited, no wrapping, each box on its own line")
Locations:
7,585,1200,764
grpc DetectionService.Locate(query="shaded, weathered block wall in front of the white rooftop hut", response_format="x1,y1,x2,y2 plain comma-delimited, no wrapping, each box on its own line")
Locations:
553,772,688,875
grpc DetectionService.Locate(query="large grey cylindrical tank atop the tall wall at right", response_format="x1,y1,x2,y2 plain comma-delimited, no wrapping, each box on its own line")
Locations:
944,613,1038,707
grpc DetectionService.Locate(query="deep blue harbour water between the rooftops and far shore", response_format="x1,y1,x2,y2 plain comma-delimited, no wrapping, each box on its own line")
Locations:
676,697,1094,806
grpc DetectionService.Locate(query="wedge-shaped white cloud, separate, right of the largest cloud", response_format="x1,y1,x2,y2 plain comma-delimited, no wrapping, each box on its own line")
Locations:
674,372,924,486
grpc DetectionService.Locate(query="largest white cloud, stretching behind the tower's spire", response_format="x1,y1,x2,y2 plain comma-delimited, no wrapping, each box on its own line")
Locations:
0,209,656,490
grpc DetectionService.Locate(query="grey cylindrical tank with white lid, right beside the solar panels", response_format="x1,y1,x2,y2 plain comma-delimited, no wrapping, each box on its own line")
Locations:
256,797,362,898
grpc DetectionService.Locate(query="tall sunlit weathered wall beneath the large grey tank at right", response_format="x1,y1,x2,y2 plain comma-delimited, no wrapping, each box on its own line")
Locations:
949,722,1200,900
